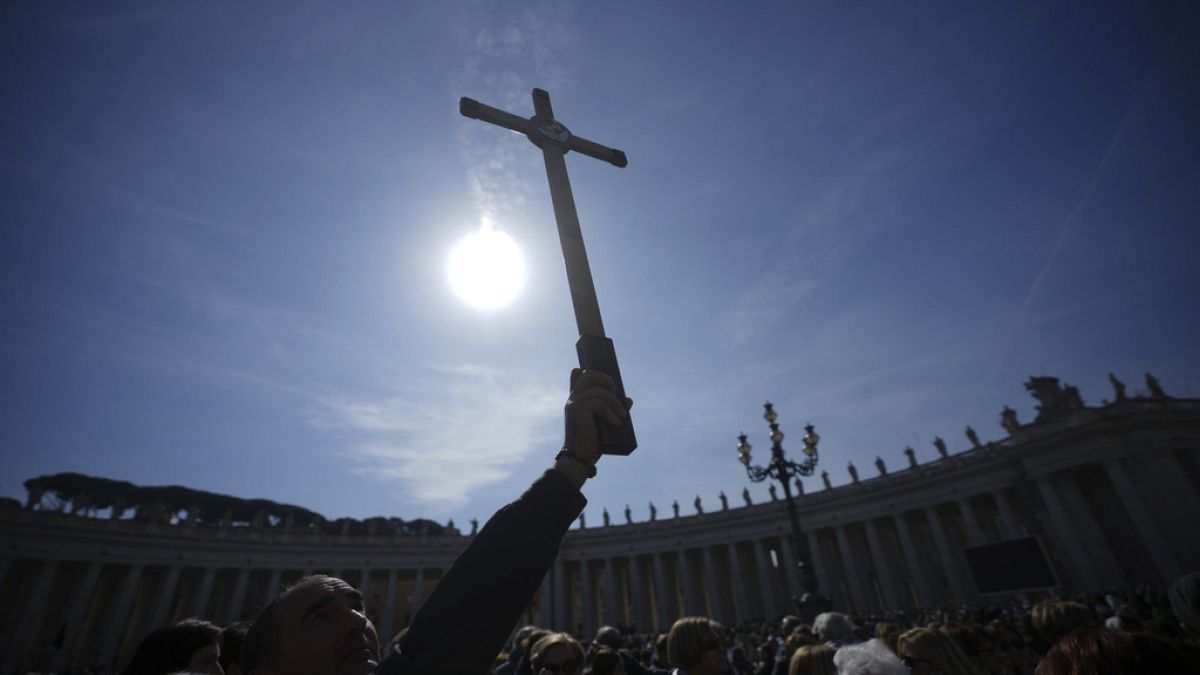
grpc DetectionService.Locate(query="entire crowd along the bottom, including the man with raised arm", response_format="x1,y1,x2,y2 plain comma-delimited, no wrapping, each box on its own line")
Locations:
51,371,1200,675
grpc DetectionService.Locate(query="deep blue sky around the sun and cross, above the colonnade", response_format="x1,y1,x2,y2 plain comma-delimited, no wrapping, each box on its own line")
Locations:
0,2,1200,525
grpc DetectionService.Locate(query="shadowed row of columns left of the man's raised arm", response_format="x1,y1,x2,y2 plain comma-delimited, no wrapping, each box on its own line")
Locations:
0,558,442,673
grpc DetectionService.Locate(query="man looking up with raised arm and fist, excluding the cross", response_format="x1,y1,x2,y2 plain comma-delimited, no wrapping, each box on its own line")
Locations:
241,369,632,675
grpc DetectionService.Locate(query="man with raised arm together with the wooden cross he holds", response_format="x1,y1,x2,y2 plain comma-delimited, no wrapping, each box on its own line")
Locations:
241,89,638,675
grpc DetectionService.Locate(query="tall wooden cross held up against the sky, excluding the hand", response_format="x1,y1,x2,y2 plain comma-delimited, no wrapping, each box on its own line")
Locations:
458,89,637,455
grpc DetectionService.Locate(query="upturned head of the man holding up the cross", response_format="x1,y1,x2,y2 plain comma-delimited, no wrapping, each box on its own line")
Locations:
269,571,379,675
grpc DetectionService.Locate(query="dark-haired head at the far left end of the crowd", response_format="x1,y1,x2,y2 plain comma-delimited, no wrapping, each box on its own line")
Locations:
122,619,224,675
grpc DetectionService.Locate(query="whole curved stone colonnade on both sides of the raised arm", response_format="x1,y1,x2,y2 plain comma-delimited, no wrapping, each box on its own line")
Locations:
0,381,1200,673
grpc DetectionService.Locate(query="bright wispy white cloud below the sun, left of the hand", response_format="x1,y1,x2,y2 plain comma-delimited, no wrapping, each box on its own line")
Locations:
313,364,563,508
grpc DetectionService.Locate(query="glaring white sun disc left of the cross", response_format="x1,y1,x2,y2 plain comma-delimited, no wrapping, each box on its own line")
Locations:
446,220,526,310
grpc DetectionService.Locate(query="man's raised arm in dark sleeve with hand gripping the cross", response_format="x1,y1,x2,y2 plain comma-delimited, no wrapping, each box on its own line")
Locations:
379,370,629,675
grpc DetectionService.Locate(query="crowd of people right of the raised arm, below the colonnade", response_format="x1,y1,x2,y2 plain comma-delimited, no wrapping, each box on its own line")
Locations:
482,573,1200,675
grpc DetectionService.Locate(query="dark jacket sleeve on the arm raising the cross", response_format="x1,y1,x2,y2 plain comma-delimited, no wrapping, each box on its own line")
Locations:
378,471,587,675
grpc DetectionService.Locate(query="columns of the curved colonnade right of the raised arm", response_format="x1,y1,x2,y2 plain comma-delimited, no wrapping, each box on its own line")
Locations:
533,454,1200,635
